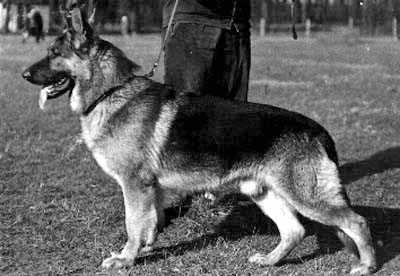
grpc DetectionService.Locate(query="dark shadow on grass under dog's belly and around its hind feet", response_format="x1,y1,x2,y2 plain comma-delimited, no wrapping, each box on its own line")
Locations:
138,204,400,265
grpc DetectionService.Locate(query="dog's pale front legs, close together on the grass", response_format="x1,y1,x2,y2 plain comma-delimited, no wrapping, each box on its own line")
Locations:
102,175,160,269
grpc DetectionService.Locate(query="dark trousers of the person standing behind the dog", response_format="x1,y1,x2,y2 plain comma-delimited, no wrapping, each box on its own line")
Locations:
164,23,250,101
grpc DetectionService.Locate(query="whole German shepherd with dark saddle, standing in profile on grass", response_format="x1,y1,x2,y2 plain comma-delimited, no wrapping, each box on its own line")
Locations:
23,5,376,275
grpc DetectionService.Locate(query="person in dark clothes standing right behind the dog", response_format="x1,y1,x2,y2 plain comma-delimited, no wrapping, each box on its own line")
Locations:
163,0,251,101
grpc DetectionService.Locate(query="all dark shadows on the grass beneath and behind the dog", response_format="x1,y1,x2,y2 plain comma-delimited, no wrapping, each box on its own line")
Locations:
138,147,400,265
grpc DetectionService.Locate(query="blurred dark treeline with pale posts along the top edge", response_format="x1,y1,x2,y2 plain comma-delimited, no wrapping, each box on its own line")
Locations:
0,0,400,37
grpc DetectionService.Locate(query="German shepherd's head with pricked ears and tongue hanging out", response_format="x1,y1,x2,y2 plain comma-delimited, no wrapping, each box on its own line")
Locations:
22,7,95,107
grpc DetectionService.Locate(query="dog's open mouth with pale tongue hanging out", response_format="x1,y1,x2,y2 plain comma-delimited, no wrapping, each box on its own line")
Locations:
39,77,75,109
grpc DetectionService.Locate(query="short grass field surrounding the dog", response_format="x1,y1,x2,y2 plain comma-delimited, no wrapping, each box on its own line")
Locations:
0,31,400,276
